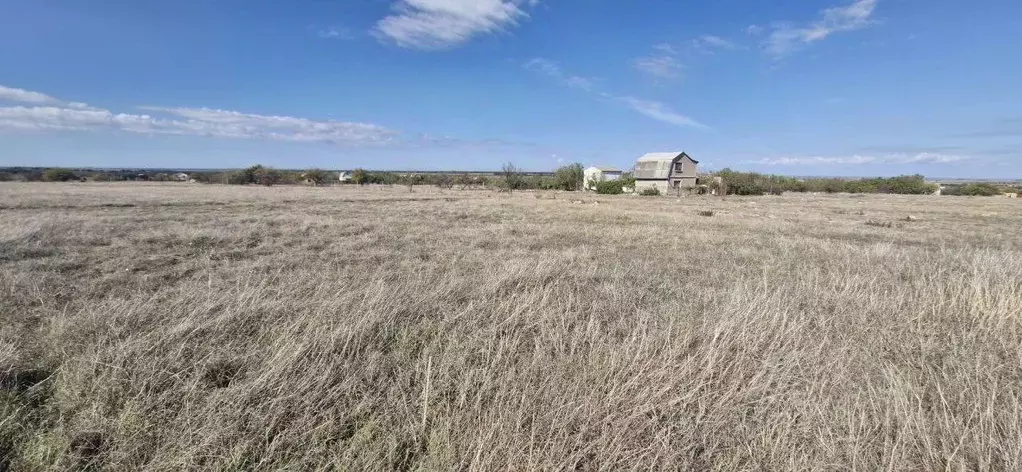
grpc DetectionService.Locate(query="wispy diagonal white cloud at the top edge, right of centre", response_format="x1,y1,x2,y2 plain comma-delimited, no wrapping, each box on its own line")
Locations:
763,0,879,57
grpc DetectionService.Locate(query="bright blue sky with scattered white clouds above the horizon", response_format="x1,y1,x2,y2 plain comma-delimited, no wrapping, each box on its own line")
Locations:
0,0,1022,178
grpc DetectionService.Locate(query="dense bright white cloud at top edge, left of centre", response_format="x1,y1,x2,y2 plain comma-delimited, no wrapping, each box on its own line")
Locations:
373,0,538,50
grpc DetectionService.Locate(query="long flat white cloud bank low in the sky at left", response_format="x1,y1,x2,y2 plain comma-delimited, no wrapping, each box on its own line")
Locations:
0,84,398,144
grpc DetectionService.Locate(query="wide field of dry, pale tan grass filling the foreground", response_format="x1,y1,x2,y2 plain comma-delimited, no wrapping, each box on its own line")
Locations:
0,184,1022,471
